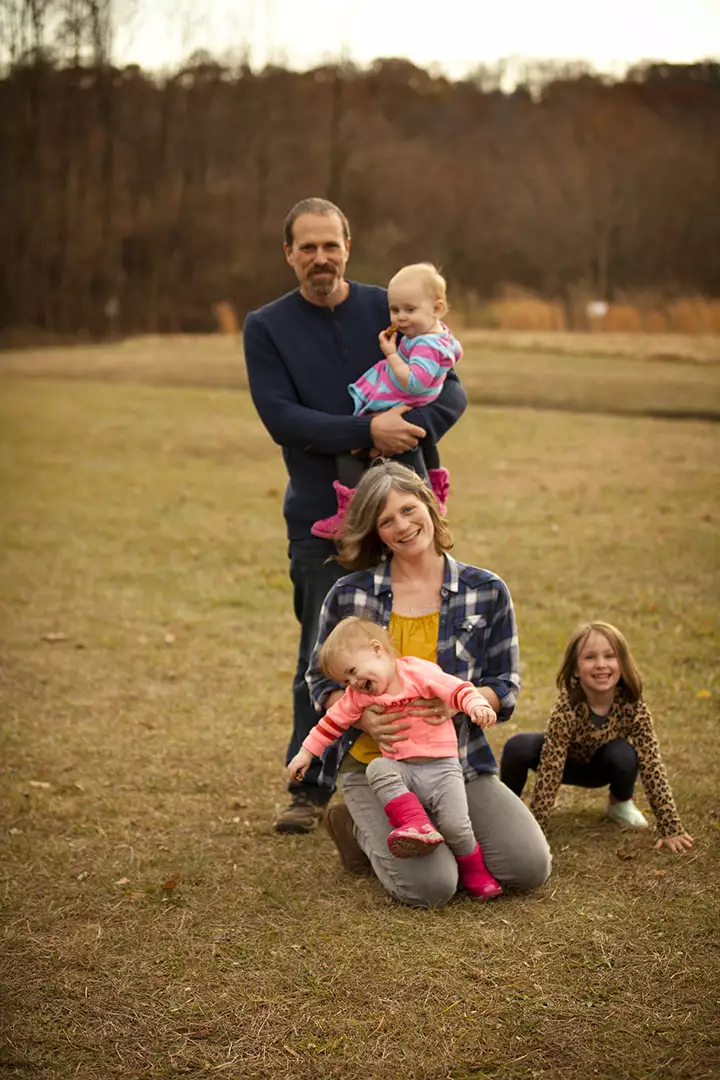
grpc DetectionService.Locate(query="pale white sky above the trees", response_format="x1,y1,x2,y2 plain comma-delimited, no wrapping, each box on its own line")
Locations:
116,0,720,77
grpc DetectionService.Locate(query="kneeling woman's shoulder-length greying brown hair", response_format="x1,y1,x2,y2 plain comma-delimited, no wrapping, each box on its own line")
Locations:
336,458,452,570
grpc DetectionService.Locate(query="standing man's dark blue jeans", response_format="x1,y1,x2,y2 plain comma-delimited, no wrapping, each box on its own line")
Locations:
285,537,348,804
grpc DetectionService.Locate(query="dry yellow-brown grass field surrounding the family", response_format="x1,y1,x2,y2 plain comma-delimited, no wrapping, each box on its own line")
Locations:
0,337,720,1080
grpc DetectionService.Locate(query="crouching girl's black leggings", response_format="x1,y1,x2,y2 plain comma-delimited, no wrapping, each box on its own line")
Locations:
500,731,638,802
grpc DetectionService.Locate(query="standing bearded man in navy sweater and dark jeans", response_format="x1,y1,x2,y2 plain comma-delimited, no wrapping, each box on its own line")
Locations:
244,199,466,833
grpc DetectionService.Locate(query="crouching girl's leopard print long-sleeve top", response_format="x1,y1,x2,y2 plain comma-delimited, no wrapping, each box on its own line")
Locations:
530,689,684,836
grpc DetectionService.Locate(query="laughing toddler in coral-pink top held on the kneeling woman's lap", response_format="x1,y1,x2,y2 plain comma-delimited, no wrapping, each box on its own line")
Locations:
287,616,502,901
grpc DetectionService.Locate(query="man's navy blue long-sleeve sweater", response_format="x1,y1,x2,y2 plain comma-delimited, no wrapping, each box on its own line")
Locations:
244,282,466,540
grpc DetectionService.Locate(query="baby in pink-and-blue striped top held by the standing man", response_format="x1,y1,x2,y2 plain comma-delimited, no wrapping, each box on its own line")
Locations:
311,262,462,540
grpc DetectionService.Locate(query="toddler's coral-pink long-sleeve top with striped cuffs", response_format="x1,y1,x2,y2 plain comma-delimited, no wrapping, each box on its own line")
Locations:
302,657,487,760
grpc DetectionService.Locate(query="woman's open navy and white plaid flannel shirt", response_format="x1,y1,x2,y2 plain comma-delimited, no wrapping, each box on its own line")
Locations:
305,555,520,788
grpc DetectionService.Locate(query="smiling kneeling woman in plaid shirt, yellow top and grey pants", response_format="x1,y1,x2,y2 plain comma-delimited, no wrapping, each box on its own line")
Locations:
308,462,551,907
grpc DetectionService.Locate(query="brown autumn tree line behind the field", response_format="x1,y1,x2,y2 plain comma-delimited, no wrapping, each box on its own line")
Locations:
0,8,720,335
